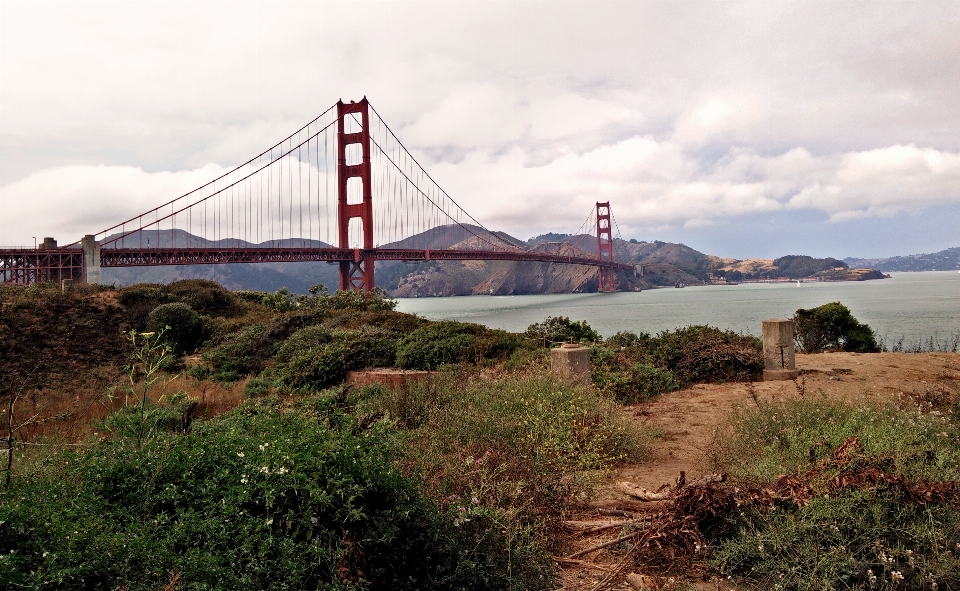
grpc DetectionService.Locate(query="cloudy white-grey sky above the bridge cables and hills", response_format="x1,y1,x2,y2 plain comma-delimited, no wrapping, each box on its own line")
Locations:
0,0,960,258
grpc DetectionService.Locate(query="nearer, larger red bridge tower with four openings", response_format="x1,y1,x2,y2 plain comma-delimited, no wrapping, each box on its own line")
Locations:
337,97,374,291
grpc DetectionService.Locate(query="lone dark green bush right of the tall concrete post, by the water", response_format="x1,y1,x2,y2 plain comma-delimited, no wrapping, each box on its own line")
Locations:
793,302,880,353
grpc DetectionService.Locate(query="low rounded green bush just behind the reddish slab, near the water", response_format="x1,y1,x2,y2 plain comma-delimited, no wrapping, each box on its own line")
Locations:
397,320,521,370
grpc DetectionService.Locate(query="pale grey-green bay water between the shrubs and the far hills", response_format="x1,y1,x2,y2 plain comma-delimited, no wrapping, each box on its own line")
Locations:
397,271,960,345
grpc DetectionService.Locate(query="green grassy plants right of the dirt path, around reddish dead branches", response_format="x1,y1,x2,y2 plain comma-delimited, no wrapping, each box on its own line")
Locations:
711,400,960,590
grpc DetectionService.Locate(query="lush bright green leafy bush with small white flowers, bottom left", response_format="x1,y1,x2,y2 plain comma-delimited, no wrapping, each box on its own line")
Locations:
0,399,532,591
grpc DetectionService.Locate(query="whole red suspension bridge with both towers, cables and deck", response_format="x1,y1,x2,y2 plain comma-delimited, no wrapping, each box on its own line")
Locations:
0,98,634,291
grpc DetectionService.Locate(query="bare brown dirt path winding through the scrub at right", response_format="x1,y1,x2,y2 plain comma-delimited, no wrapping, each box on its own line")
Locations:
561,353,960,591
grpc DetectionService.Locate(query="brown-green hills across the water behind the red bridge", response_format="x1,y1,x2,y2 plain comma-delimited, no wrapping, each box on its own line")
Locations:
94,225,888,297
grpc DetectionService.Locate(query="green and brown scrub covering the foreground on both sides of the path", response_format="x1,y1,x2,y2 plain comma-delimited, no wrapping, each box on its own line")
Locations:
0,281,960,591
